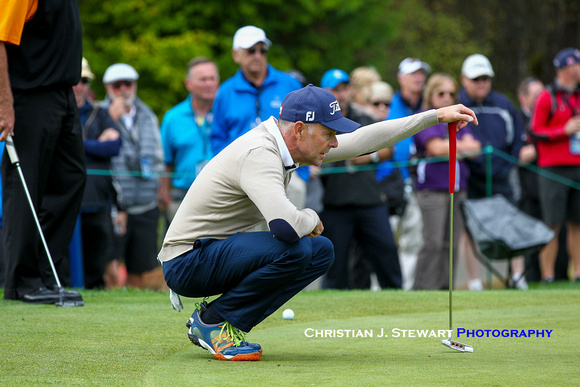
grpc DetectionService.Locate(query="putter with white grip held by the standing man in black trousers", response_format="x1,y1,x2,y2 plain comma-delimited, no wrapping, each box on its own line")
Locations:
6,135,84,306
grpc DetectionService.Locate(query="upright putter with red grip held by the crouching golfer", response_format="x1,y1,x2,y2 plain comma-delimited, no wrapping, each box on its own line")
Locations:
441,122,473,352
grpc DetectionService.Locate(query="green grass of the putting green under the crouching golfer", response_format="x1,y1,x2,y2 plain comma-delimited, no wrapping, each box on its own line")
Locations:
0,283,580,386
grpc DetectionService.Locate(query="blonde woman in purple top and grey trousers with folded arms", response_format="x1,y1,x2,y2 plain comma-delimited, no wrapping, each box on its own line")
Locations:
413,73,481,290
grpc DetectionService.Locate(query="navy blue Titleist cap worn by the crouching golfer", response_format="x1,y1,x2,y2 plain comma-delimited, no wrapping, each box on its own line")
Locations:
280,84,360,133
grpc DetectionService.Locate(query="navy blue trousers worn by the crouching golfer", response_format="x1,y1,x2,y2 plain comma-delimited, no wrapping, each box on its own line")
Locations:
163,232,334,332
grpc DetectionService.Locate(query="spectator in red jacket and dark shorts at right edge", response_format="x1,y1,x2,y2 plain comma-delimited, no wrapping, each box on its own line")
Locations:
532,48,580,282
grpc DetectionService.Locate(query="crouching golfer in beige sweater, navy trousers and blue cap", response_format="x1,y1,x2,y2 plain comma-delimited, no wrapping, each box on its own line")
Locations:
159,85,477,360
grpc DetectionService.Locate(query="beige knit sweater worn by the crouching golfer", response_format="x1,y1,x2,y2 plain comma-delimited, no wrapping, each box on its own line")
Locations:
159,110,439,262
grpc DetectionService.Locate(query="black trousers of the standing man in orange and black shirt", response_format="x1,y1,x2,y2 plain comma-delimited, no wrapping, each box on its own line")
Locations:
2,87,86,299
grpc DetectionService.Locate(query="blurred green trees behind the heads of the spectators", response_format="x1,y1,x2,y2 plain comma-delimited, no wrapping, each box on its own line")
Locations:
79,0,580,118
